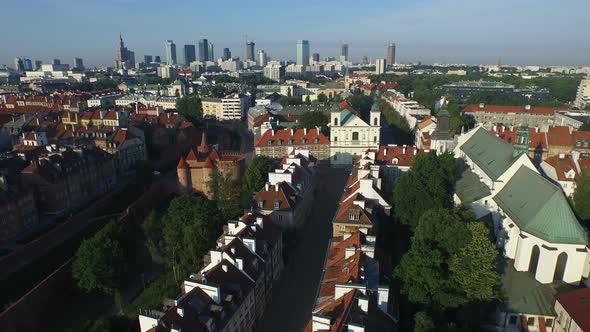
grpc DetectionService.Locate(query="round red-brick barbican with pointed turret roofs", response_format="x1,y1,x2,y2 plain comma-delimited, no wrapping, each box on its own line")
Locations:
176,133,244,199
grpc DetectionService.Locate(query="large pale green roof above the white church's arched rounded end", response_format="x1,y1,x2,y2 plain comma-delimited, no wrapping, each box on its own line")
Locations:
494,166,588,245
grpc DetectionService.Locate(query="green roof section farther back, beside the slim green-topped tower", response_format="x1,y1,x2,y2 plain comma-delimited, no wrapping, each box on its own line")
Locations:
461,128,517,180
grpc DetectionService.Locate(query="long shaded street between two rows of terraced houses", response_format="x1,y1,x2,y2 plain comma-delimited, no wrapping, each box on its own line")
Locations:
257,168,349,332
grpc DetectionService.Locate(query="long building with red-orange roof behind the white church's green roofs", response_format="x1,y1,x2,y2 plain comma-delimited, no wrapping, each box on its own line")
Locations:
463,104,564,131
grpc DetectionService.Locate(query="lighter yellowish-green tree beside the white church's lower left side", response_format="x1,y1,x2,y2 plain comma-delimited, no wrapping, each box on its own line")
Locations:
449,222,500,302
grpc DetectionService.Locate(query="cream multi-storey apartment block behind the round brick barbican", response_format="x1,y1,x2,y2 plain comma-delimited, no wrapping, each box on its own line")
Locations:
201,94,250,121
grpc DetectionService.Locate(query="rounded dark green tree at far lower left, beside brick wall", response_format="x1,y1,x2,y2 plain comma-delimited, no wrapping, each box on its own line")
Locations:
72,223,125,295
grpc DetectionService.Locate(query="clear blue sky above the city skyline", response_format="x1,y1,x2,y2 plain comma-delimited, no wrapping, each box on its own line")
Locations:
0,0,590,67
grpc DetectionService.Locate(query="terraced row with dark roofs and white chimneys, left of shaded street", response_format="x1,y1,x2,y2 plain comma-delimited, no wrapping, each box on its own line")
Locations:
139,213,283,332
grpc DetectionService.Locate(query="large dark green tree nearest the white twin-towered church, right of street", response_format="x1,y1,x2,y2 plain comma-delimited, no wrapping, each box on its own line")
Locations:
393,152,456,228
